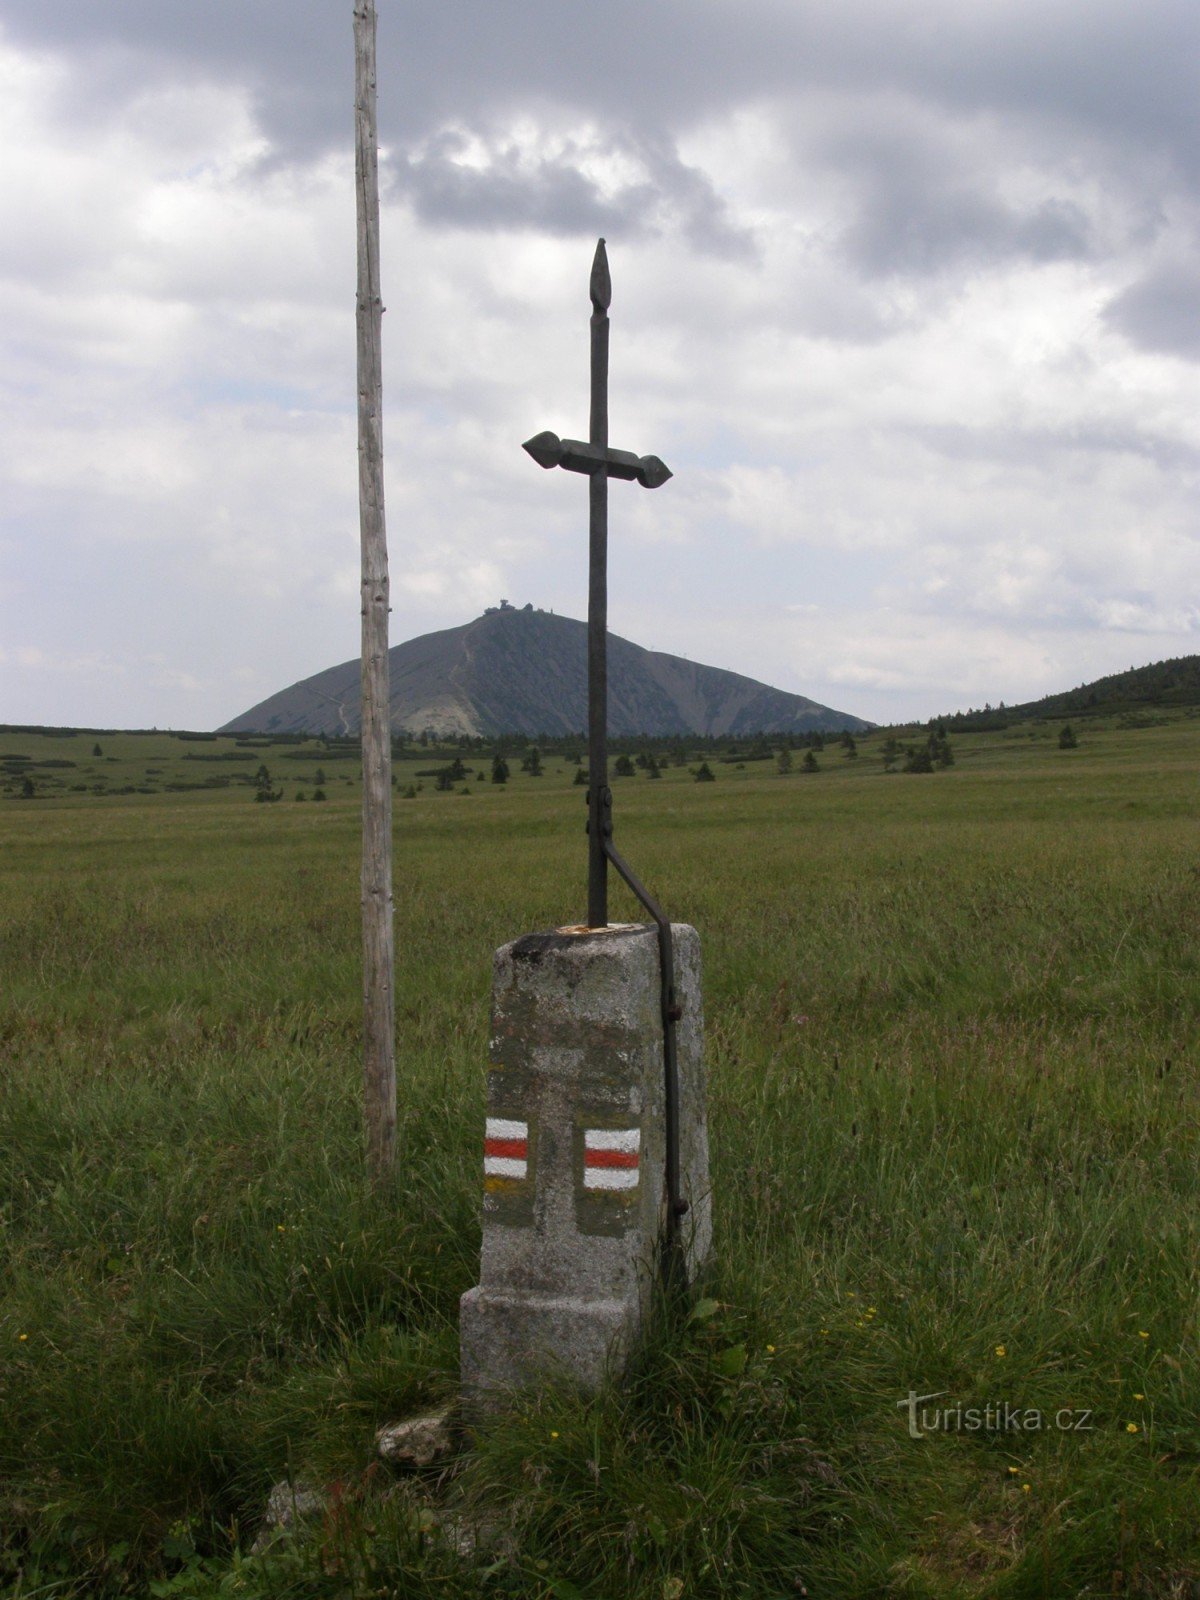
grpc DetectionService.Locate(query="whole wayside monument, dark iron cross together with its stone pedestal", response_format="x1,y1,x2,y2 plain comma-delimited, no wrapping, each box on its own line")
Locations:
461,238,712,1410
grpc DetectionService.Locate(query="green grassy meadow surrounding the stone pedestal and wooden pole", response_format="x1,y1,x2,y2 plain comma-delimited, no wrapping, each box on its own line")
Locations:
0,712,1200,1600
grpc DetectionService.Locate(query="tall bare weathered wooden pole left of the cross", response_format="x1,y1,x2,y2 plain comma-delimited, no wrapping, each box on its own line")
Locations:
354,0,395,1181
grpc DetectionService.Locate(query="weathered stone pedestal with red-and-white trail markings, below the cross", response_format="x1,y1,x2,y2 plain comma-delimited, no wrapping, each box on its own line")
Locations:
461,925,712,1405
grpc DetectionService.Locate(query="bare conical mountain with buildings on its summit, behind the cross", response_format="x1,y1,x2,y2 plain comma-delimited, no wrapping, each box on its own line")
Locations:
219,605,870,736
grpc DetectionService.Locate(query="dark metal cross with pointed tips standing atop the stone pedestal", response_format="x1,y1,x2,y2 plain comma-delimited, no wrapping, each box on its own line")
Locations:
523,238,670,928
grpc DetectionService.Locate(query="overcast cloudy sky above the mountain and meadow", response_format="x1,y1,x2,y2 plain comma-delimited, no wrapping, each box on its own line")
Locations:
0,0,1200,728
